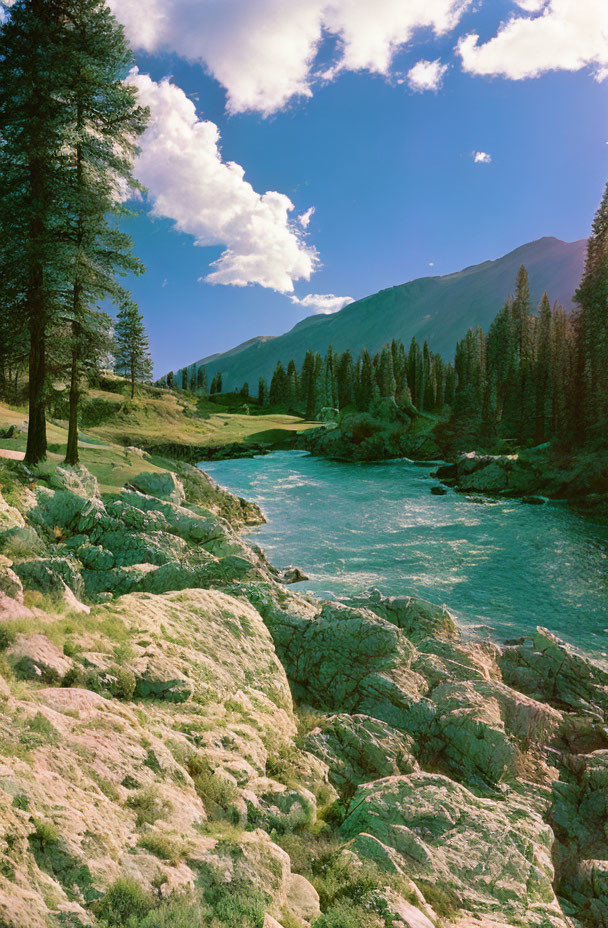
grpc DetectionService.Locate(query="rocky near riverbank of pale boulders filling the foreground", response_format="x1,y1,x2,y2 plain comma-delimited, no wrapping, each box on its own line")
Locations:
0,464,608,928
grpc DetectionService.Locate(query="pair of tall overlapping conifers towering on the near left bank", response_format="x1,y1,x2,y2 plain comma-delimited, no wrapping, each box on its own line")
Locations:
0,0,151,464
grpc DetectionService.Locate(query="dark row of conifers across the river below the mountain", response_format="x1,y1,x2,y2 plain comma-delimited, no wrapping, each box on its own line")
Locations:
165,179,608,454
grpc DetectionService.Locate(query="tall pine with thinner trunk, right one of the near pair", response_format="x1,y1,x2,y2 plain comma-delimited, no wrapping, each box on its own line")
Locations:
57,0,147,464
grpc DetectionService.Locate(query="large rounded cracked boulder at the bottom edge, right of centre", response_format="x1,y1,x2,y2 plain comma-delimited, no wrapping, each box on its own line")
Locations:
342,773,567,928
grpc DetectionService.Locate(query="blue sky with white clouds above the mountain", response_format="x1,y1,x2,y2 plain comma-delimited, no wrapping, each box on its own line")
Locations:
107,0,608,374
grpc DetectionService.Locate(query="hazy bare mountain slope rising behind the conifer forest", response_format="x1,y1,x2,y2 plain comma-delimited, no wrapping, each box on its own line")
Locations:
188,238,587,392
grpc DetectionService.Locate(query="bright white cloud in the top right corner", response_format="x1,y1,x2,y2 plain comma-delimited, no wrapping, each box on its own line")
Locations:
458,0,608,80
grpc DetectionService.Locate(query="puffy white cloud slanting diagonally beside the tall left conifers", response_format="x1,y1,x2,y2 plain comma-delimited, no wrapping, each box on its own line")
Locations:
129,69,318,293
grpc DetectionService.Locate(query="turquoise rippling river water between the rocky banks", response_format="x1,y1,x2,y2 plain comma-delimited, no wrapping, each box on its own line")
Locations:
200,451,608,658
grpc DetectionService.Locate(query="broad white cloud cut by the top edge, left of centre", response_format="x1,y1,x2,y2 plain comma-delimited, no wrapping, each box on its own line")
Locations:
110,0,472,115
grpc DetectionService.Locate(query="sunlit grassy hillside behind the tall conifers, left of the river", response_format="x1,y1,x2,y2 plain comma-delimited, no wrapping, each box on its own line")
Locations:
0,378,318,489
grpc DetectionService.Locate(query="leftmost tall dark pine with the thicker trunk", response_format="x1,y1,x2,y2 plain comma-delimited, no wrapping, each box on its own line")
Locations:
0,0,71,464
